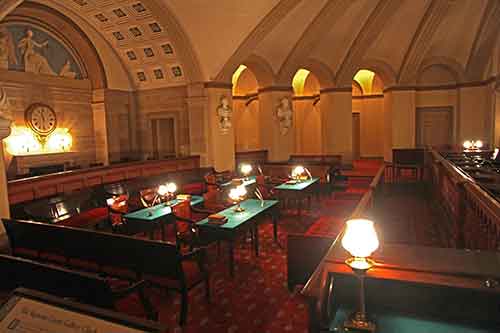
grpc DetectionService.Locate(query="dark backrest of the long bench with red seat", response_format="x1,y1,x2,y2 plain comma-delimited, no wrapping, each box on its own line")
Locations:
3,219,184,280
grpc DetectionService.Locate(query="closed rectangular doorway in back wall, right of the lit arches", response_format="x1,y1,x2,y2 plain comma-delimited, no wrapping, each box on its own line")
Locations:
416,107,453,147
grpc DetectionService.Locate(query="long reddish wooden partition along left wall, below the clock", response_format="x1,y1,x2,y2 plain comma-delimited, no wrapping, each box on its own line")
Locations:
8,156,200,205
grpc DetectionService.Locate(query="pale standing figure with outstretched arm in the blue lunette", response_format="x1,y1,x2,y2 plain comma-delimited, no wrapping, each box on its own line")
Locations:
17,30,57,75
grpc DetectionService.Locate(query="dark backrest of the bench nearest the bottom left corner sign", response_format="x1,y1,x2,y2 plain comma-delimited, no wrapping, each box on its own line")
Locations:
0,254,113,308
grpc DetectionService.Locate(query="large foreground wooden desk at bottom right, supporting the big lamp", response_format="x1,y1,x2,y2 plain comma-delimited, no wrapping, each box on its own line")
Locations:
303,244,500,333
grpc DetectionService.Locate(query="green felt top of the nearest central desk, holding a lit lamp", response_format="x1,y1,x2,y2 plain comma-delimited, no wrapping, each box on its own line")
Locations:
198,199,278,229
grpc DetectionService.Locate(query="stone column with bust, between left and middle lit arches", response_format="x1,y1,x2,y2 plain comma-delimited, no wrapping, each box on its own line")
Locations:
259,87,296,162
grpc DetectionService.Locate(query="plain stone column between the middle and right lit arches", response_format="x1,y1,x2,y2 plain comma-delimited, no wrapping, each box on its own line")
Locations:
320,87,352,164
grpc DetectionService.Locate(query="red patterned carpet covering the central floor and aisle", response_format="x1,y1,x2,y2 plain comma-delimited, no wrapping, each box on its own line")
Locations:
117,161,406,333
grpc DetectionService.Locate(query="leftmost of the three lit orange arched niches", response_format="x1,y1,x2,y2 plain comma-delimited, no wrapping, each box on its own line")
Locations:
232,65,260,152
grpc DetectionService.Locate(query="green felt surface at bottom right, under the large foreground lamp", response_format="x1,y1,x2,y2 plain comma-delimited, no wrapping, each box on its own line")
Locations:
330,308,499,333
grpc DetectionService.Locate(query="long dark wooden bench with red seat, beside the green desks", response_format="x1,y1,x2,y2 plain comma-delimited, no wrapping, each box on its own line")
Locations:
3,219,210,325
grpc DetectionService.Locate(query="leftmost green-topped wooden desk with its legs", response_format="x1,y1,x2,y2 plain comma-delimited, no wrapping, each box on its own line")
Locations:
123,195,204,240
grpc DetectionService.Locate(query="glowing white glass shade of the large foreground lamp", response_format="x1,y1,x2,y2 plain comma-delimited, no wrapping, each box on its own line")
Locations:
342,219,379,258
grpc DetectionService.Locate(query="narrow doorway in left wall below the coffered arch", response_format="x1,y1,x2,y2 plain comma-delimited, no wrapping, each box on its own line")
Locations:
151,118,176,159
